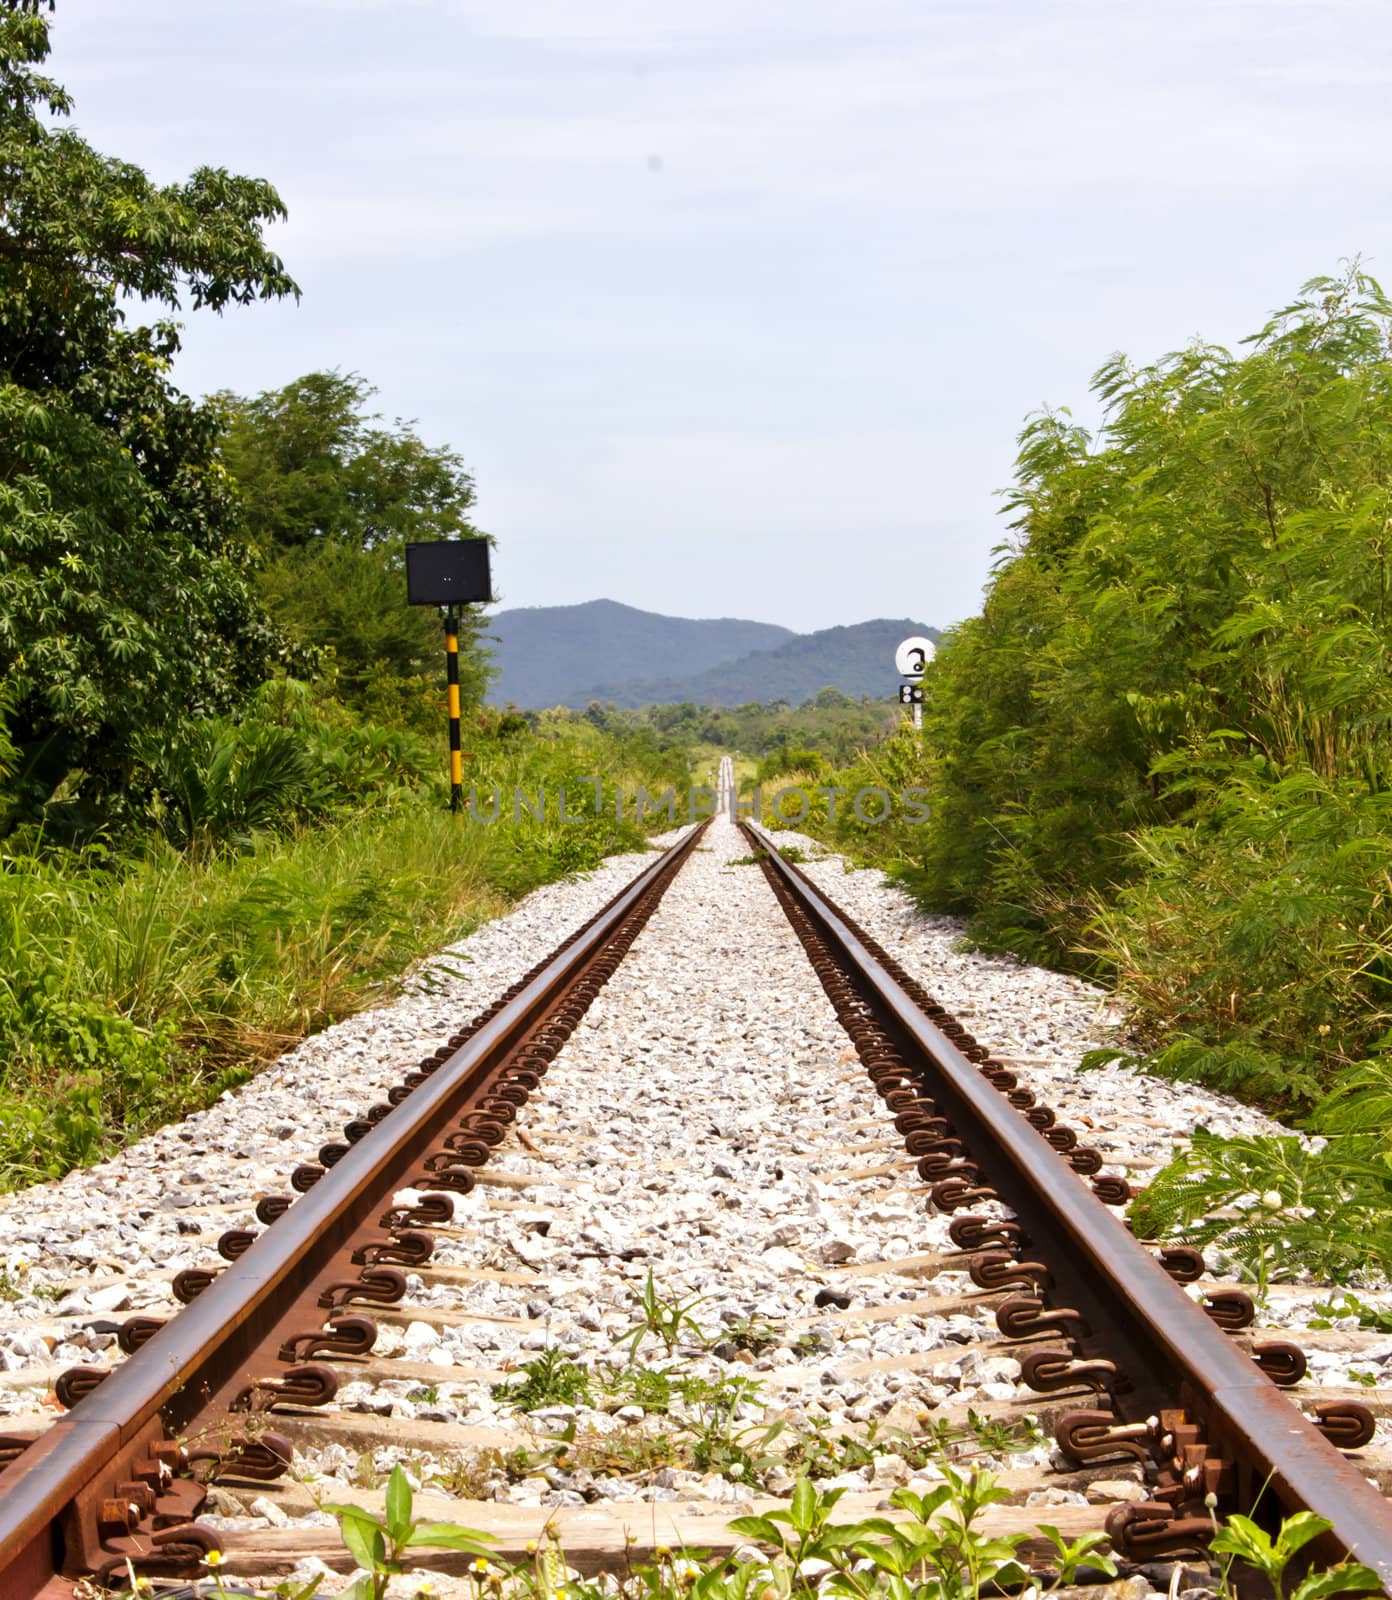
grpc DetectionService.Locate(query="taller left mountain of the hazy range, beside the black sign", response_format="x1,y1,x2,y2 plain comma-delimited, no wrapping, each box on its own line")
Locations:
490,600,797,709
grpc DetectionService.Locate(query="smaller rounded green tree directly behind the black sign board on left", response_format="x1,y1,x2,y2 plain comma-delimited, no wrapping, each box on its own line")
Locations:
221,373,486,720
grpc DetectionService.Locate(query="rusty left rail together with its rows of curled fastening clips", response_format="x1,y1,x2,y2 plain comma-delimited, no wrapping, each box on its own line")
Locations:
0,824,706,1600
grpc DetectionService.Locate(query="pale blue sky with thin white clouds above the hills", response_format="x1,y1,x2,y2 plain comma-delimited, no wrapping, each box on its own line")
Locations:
43,0,1392,630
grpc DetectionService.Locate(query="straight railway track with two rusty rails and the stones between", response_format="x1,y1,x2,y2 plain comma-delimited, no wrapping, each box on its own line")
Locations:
0,806,1392,1600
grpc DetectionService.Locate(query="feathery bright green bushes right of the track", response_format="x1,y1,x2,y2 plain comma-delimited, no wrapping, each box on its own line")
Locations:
838,266,1392,1126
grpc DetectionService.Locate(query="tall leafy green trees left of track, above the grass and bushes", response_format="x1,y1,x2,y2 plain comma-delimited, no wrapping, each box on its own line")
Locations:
0,0,499,843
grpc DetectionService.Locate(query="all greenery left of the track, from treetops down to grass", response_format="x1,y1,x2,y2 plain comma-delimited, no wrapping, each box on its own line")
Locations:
0,0,686,1186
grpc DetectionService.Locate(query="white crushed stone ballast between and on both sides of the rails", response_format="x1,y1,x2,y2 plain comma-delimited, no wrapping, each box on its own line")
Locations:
0,819,1392,1568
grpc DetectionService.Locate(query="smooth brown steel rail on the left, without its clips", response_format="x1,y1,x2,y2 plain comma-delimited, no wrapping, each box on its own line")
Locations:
0,824,706,1600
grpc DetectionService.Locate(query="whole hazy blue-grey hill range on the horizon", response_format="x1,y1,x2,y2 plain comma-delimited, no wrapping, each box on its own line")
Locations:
490,600,938,709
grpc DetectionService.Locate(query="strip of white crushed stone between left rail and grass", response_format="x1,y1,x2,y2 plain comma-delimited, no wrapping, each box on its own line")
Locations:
0,834,678,1363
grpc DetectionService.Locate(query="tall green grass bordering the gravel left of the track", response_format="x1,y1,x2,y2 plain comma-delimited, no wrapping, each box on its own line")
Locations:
0,725,680,1187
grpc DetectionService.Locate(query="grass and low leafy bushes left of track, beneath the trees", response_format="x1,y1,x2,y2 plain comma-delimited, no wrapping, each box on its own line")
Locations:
0,707,682,1187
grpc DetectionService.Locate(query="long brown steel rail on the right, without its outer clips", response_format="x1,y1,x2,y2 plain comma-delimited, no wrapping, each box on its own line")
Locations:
742,824,1392,1594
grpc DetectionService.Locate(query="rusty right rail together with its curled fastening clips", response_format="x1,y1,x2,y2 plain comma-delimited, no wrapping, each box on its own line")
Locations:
741,824,1392,1594
